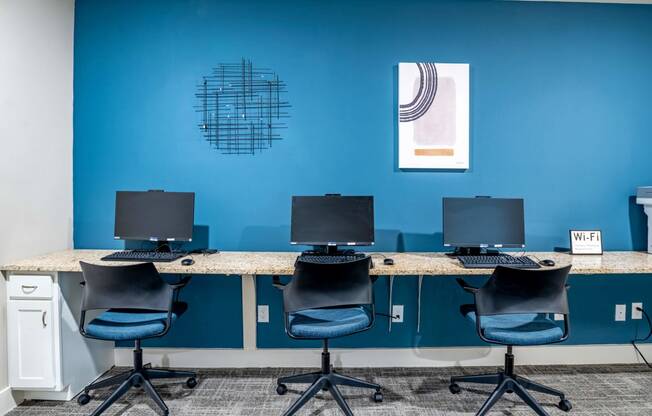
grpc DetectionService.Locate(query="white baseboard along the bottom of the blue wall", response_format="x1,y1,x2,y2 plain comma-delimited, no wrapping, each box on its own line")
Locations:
115,344,652,368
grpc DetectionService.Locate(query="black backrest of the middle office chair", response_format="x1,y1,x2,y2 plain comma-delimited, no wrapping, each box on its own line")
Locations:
283,257,374,314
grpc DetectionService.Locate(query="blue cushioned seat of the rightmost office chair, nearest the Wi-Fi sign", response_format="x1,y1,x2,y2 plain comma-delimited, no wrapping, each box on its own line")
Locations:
466,311,564,345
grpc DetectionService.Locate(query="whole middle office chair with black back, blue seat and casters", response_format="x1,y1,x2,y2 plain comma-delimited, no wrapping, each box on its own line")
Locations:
274,257,383,416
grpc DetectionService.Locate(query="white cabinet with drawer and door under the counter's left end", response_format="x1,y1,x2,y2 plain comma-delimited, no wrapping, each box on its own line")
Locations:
5,272,114,400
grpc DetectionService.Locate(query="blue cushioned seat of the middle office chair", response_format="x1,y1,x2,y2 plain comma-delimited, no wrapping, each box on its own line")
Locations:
288,306,371,339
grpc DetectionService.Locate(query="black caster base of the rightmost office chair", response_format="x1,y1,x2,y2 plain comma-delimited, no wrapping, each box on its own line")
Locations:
449,346,572,416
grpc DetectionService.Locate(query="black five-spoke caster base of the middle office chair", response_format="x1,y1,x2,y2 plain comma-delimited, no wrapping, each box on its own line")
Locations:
276,340,383,416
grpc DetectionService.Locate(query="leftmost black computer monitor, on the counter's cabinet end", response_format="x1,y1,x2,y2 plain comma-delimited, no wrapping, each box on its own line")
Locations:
114,191,195,242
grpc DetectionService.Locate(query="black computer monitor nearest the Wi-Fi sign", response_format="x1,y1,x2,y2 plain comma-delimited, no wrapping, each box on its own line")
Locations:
443,198,525,248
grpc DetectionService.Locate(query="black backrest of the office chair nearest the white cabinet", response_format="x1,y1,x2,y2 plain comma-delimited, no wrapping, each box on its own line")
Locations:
80,262,173,312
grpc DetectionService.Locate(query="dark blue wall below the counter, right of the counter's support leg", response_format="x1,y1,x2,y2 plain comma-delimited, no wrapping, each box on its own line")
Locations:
257,275,652,348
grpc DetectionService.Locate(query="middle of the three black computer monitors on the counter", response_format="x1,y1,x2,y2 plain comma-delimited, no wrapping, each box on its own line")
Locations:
290,195,375,246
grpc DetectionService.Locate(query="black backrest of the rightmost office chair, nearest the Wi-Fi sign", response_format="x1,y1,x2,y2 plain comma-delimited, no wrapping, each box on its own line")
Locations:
475,266,571,316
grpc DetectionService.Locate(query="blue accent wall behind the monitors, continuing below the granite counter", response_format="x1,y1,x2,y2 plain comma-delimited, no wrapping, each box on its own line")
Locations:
74,0,652,347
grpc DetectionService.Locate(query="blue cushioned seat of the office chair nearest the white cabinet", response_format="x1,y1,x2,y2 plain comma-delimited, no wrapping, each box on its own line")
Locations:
86,305,185,341
